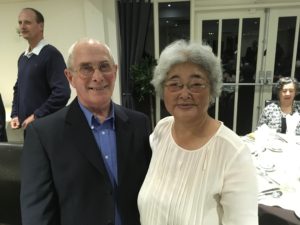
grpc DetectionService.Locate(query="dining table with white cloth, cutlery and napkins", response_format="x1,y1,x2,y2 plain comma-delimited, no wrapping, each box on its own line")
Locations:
242,128,300,225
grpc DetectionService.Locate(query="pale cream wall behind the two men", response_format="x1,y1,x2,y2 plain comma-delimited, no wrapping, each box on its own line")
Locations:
0,0,120,120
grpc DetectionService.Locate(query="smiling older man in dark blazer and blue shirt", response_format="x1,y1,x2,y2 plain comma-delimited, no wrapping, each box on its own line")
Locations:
21,39,151,225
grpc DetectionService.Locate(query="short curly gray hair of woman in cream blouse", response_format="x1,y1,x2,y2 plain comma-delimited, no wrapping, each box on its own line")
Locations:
151,40,222,103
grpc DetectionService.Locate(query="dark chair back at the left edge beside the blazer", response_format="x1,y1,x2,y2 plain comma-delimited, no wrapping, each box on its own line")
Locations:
0,142,23,225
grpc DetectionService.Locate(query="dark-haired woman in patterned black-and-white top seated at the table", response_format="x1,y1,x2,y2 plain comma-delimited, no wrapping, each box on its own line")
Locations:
258,77,300,135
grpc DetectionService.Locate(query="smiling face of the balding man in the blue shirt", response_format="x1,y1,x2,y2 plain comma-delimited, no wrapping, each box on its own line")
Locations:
66,42,117,112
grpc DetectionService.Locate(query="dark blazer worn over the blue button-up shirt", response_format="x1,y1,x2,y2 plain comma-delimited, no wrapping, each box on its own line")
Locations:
21,99,151,225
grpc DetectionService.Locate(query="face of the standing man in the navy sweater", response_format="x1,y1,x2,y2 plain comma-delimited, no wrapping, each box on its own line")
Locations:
18,9,44,41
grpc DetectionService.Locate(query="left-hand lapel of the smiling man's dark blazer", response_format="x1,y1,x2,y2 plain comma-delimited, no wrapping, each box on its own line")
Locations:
65,98,109,179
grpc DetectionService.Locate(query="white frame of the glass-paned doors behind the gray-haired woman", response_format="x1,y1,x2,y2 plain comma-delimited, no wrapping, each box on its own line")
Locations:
191,5,300,134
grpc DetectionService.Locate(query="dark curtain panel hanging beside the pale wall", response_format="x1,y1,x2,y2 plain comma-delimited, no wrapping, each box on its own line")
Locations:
118,0,152,108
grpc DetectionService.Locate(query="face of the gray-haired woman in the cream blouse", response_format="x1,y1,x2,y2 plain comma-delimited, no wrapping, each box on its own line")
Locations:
164,62,210,121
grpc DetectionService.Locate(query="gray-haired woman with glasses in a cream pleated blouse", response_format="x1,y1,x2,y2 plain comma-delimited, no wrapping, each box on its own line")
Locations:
138,40,258,225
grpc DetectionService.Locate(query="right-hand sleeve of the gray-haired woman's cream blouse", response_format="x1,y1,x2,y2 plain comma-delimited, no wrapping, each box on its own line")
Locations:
220,145,258,225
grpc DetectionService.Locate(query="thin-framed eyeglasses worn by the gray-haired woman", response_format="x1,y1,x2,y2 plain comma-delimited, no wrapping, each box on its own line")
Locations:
164,80,208,93
